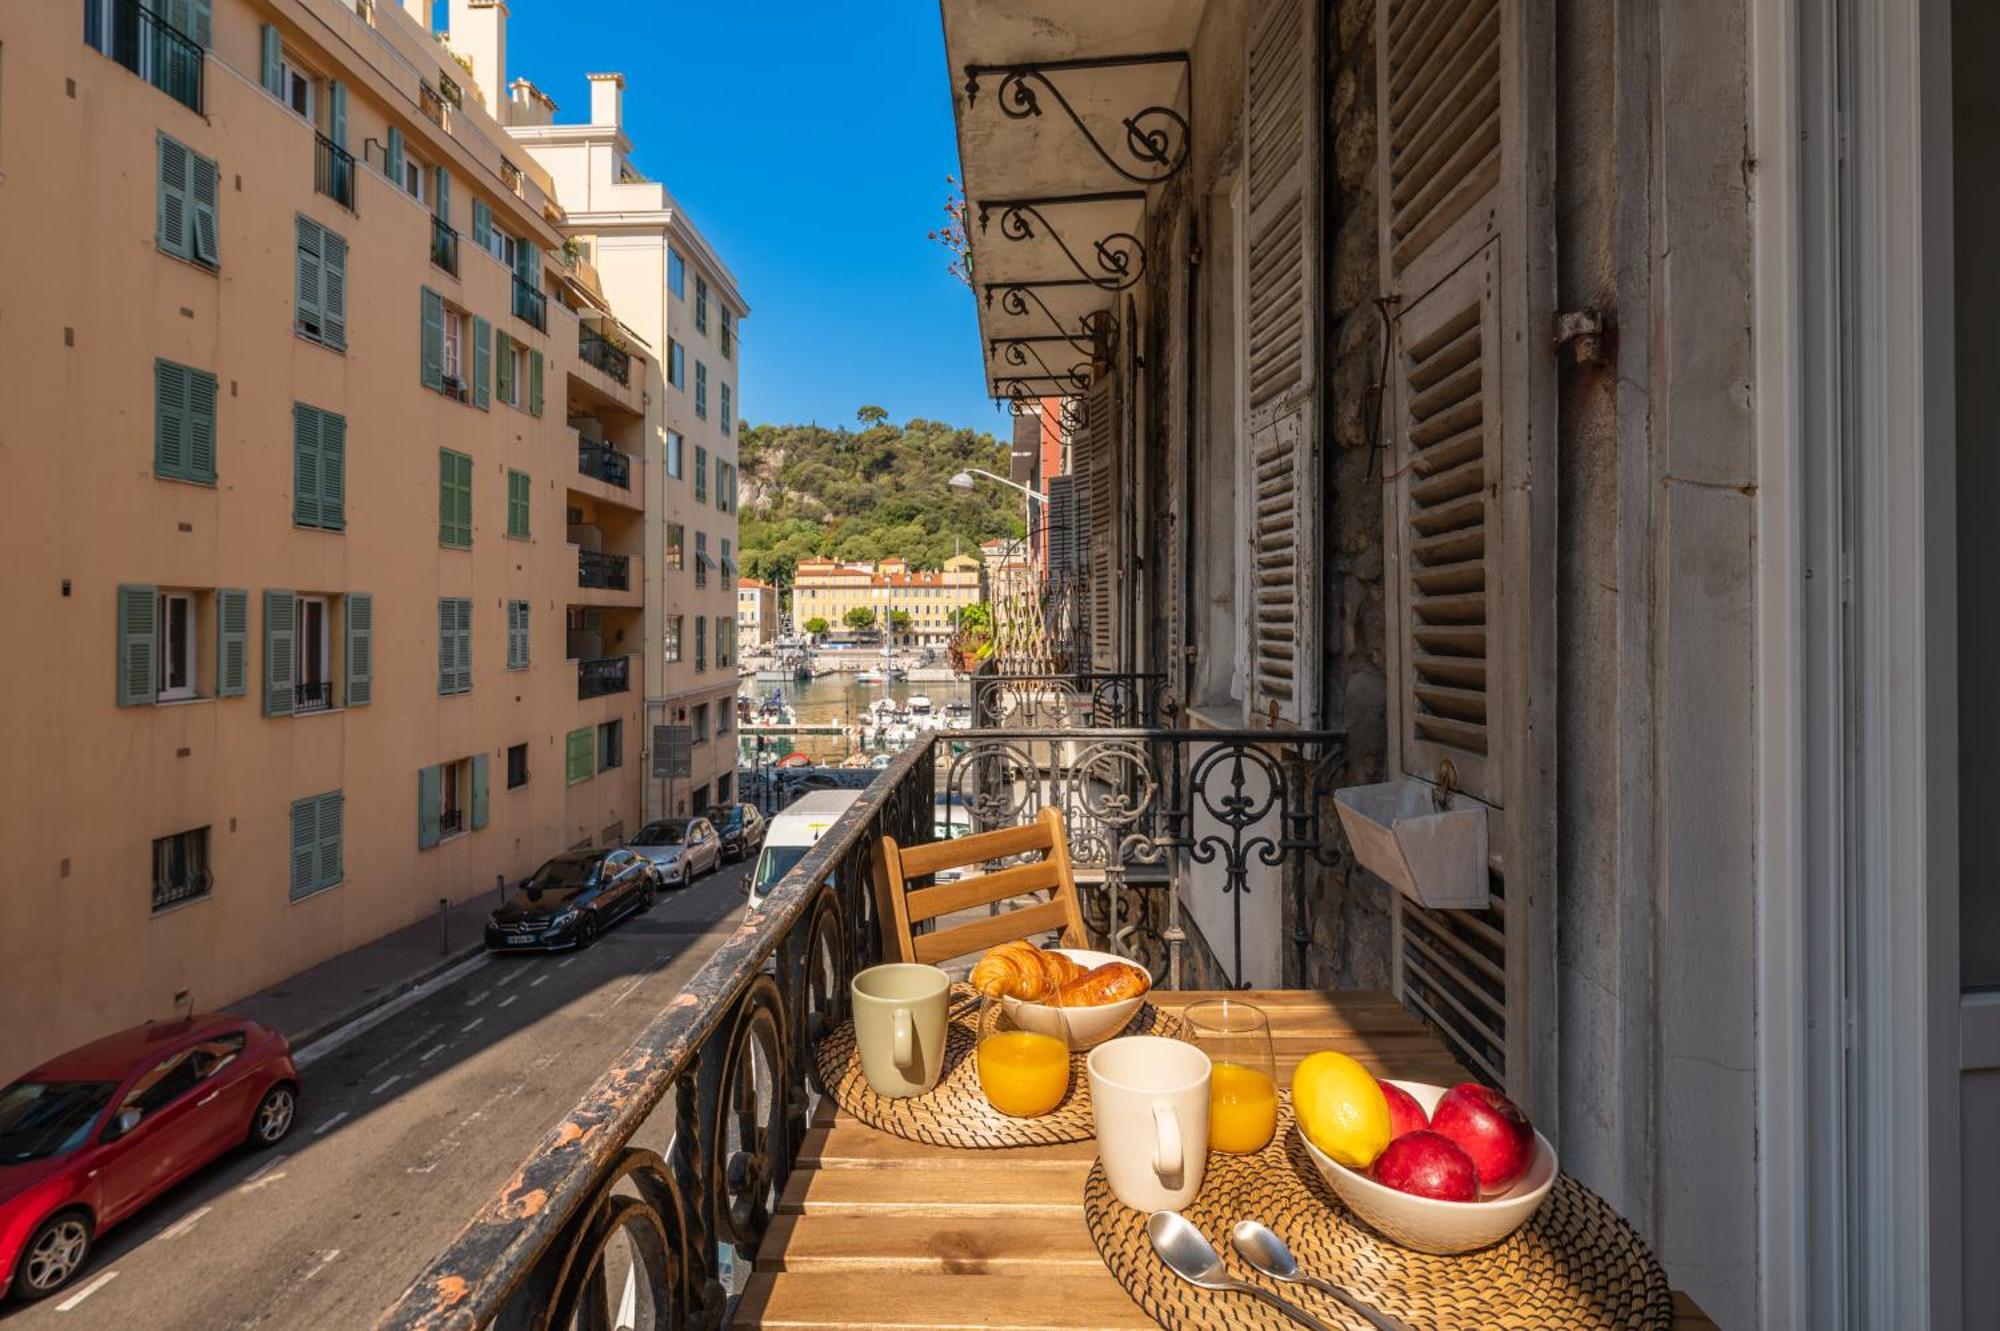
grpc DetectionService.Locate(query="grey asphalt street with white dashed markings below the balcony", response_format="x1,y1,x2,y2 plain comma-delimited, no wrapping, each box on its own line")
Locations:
0,865,746,1331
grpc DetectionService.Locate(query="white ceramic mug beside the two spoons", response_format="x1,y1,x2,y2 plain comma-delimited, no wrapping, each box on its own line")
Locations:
1088,1035,1210,1211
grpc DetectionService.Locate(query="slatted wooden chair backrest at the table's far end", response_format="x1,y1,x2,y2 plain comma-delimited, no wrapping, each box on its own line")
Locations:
876,807,1086,963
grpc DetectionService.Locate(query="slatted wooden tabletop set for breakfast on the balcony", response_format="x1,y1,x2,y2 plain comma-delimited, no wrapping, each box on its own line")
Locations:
736,989,1714,1331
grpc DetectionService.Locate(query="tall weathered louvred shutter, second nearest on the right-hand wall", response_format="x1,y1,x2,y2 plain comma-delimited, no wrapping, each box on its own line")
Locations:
1242,0,1326,725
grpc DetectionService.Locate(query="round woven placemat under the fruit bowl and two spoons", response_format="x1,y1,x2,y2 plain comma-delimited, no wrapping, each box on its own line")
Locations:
1084,1093,1672,1331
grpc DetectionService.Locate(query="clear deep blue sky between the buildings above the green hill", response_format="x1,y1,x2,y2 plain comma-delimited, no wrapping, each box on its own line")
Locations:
500,0,1008,432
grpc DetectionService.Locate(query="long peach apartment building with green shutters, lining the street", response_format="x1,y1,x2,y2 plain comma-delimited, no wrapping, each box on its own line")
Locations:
0,0,650,1079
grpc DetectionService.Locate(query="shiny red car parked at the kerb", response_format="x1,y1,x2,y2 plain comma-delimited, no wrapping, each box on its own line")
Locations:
0,1013,298,1299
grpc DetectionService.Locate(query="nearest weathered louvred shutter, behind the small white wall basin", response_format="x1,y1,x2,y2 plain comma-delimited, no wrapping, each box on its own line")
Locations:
1376,0,1556,1113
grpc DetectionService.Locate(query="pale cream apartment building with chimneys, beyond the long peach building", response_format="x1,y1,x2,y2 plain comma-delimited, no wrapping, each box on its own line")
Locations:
508,77,750,815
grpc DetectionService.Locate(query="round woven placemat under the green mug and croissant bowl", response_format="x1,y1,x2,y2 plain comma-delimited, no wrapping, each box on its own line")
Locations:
814,983,1188,1151
